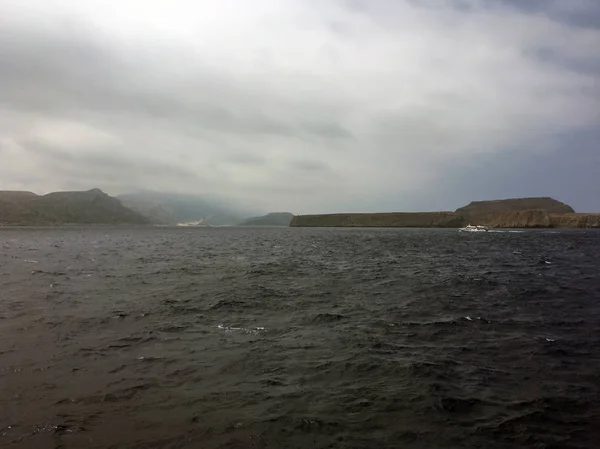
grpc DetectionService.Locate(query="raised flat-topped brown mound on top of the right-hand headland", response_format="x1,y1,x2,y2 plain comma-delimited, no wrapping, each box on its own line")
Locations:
456,197,575,215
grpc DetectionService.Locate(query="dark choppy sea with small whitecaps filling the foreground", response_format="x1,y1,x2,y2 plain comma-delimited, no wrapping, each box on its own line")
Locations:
0,228,600,449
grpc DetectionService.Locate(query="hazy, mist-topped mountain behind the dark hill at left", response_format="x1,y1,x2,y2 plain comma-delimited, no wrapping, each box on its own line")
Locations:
117,191,244,226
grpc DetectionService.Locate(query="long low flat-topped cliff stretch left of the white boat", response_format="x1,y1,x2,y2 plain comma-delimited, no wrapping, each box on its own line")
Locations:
290,212,465,228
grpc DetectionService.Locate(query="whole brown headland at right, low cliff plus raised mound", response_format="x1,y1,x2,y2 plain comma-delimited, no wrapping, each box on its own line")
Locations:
290,197,600,228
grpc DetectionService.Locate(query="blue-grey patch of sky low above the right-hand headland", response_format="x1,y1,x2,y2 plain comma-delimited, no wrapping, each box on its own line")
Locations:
414,128,600,212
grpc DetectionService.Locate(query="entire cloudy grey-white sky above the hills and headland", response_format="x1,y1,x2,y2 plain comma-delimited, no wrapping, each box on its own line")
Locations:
0,0,600,213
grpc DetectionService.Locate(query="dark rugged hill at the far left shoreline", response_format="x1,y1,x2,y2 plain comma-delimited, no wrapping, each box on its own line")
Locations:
0,189,148,225
